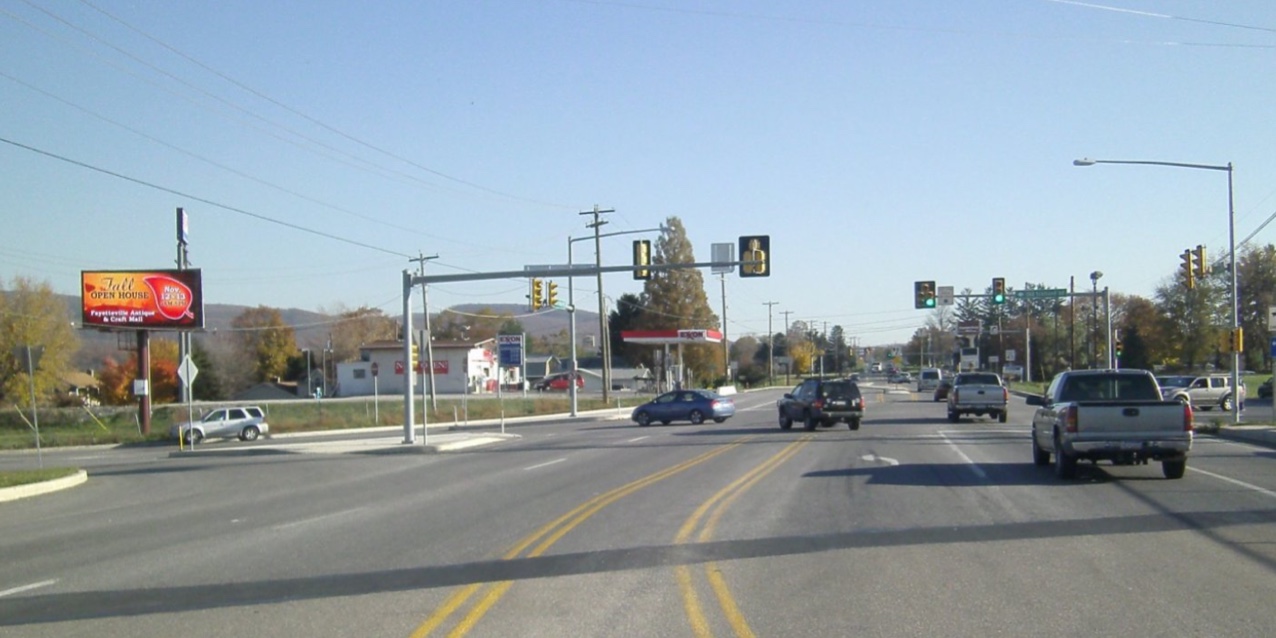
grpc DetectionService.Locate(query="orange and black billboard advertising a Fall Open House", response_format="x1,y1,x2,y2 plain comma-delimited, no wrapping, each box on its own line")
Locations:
80,269,204,330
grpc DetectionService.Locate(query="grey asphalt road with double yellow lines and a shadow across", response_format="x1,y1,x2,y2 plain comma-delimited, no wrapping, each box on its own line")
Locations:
0,390,1276,638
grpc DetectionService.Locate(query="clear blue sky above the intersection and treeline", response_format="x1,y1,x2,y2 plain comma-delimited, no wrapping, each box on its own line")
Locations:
0,0,1276,345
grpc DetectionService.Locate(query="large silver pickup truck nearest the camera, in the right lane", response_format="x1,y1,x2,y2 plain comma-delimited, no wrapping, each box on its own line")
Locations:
1027,370,1193,479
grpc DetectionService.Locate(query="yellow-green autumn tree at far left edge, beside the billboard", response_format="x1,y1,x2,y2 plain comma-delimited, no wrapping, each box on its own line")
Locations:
0,277,79,407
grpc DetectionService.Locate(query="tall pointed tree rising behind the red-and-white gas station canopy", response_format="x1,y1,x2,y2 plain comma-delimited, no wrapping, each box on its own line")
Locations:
635,217,725,384
